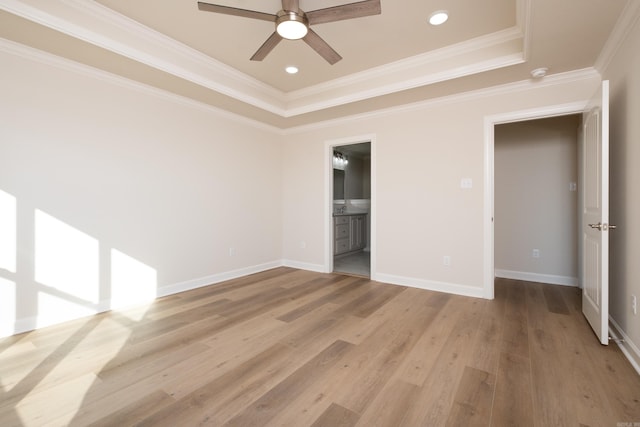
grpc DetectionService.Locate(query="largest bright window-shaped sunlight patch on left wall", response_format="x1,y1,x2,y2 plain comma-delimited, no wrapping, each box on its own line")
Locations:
35,209,100,304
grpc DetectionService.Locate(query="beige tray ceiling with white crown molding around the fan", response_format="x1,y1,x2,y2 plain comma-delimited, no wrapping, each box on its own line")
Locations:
0,0,636,128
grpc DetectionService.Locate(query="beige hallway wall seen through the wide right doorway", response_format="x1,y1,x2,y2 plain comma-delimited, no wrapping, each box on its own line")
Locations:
494,115,580,286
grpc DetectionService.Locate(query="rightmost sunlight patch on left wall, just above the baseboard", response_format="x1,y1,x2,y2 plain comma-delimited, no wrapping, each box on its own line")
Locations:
111,249,158,320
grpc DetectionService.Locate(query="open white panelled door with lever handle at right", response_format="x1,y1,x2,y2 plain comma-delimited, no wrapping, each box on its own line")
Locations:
582,80,615,345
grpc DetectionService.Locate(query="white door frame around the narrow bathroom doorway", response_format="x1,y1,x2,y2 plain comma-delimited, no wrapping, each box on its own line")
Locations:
323,134,377,280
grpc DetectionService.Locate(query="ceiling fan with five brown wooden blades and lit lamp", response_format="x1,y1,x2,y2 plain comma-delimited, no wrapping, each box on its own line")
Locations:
198,0,382,65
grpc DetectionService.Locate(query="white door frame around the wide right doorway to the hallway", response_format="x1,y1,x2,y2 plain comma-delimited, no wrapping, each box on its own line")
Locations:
483,100,589,299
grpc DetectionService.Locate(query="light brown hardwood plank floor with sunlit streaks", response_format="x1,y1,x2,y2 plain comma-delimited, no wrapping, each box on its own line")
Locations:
0,268,640,427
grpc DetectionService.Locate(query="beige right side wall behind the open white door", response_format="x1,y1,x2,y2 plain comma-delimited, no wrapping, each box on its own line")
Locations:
603,14,640,362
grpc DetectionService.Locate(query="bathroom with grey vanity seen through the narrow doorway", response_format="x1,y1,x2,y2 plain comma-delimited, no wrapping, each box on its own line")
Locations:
331,142,372,277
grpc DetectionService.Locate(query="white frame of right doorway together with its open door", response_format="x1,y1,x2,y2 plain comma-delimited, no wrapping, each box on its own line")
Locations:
484,84,615,345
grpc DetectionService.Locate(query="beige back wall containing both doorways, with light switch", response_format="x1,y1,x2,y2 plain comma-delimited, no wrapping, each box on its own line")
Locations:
283,79,599,296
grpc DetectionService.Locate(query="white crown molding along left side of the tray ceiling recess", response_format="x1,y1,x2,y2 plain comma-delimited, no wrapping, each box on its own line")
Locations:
0,0,285,116
